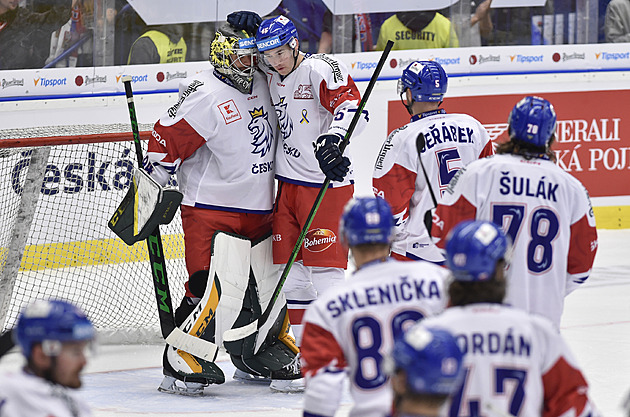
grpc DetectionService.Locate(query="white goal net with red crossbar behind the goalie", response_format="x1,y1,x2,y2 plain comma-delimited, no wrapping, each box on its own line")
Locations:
0,124,187,343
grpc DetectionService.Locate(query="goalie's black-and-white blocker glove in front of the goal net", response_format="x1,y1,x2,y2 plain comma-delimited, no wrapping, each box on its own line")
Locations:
107,169,183,246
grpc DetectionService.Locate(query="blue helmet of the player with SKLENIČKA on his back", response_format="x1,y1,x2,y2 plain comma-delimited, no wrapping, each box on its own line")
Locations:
339,197,394,246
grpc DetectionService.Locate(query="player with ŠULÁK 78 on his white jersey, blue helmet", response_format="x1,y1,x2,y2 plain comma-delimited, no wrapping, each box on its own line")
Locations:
433,96,597,327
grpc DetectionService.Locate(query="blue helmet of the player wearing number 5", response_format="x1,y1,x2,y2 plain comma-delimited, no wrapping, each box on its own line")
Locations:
398,61,448,101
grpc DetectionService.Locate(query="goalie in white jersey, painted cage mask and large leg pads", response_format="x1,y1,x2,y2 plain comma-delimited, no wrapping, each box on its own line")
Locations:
145,25,300,395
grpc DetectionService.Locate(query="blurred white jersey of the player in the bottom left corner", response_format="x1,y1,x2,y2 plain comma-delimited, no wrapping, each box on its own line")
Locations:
0,371,92,417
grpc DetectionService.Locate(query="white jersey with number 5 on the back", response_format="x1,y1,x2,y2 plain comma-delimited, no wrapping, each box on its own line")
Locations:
372,110,494,262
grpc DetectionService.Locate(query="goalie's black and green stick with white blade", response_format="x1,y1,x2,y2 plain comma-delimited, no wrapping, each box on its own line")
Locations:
122,75,218,360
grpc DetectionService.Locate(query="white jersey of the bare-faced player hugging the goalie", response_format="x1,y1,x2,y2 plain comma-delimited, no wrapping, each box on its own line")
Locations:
265,54,368,187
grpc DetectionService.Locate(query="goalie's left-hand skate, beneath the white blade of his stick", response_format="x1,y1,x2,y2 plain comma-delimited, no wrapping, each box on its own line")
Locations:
158,345,225,396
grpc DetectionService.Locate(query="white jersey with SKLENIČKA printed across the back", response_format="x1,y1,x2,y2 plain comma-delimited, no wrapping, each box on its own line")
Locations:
300,258,448,417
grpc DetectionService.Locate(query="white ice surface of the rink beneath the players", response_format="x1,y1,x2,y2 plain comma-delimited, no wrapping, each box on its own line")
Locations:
0,230,630,417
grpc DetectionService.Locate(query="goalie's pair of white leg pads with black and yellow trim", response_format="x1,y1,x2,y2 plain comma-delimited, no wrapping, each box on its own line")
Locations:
160,231,301,395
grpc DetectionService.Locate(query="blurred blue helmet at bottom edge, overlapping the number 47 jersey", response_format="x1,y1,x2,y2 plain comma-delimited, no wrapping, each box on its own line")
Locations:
386,323,464,395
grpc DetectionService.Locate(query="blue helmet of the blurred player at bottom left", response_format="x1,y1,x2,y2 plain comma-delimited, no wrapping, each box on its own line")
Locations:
13,300,94,357
